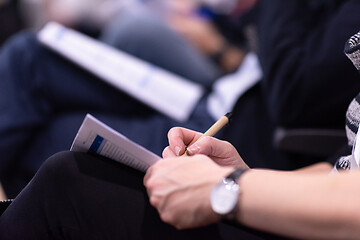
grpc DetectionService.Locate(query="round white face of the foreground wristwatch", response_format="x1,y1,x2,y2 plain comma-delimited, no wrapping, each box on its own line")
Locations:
210,178,239,215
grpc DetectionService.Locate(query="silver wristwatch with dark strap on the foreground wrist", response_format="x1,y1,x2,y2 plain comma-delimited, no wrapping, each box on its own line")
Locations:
210,168,247,220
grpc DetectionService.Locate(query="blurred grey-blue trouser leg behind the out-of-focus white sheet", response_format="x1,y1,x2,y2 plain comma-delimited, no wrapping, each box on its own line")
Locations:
101,8,220,87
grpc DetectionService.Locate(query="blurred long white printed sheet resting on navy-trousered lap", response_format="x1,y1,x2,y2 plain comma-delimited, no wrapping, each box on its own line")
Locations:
38,22,204,122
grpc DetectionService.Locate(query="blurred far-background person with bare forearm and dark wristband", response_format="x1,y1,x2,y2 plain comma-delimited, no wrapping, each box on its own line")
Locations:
155,0,257,74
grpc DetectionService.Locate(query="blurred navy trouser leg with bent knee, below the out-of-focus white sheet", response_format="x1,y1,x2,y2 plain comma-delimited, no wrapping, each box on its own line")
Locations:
0,31,146,196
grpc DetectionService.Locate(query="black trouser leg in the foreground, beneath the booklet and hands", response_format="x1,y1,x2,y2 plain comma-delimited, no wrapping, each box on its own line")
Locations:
0,152,286,240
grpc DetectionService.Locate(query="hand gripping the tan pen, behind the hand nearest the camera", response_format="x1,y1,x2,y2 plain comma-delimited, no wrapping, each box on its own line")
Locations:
163,127,249,168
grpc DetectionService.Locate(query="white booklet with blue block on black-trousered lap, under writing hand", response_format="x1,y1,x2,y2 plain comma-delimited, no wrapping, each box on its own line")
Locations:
70,114,160,172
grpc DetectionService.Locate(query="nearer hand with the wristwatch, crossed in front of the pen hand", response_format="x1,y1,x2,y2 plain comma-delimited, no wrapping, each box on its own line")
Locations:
144,155,233,229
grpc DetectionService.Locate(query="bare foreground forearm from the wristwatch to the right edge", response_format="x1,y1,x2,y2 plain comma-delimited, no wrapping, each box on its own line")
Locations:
237,170,360,239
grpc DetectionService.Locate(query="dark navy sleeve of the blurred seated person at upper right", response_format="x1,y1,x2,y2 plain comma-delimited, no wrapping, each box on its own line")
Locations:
259,0,360,128
